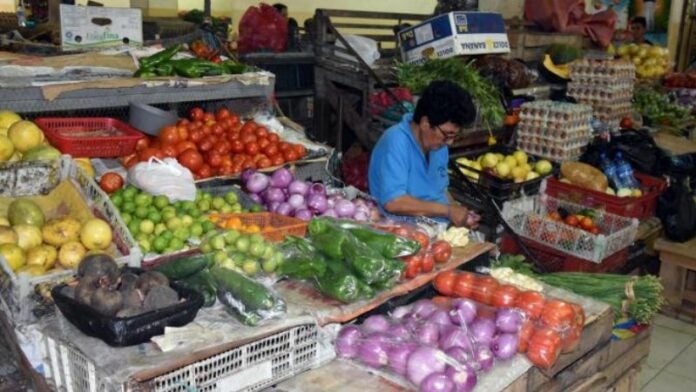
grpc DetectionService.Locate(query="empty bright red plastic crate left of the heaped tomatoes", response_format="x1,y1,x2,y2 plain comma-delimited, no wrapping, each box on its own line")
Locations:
34,117,145,158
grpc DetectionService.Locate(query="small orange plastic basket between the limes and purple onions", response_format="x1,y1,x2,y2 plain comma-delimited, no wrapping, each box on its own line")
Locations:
212,212,307,242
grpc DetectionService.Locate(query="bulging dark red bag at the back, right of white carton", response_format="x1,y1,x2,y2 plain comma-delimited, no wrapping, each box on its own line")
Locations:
238,3,288,54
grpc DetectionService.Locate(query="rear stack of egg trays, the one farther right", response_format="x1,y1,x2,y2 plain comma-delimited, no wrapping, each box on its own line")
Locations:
568,59,636,126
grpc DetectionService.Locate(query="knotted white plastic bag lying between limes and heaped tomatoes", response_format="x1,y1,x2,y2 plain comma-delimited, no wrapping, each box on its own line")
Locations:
128,158,196,201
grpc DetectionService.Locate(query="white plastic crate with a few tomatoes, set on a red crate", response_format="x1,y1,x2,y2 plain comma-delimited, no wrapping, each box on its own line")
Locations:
503,194,638,263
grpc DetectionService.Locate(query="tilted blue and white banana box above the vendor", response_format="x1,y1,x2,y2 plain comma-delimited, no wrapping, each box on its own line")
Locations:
398,11,510,64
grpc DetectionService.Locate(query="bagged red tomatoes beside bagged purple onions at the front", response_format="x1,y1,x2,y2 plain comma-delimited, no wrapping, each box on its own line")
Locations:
433,271,585,369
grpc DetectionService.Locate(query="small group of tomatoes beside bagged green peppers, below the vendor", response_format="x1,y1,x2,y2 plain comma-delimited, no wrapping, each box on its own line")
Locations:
379,225,452,279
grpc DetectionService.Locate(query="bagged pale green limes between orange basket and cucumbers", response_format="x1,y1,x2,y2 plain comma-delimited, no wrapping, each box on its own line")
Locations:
201,229,283,276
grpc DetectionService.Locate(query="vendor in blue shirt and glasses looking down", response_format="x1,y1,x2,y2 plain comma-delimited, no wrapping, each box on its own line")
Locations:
368,81,478,227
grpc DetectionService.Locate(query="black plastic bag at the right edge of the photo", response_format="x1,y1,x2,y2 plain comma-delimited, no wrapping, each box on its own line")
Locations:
657,180,696,242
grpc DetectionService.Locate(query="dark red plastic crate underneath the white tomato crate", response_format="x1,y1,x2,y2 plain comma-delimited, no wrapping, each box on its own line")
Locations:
500,233,629,273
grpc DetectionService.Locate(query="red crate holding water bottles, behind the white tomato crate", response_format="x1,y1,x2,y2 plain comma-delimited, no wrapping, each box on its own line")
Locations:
545,173,667,220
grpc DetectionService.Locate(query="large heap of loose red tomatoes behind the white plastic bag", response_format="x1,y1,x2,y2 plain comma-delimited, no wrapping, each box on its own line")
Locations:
123,108,307,179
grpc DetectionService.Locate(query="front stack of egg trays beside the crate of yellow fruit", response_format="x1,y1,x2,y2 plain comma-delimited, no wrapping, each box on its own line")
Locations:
517,101,592,161
